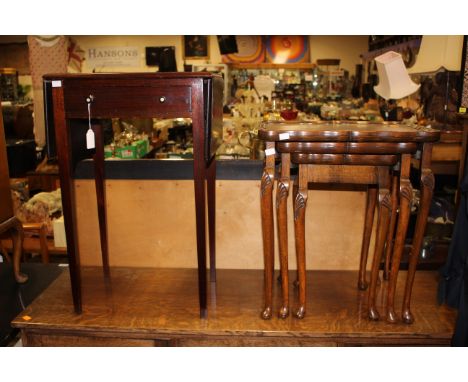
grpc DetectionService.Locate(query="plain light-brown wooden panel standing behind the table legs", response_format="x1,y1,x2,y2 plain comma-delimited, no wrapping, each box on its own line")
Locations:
75,180,372,269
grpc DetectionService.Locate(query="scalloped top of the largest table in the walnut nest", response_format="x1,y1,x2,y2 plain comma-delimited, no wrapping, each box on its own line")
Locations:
258,121,440,142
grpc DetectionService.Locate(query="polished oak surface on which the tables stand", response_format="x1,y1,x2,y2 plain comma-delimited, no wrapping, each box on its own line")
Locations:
13,267,456,346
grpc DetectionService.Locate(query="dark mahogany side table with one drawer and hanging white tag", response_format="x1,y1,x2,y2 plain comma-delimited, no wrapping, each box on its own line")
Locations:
44,73,224,318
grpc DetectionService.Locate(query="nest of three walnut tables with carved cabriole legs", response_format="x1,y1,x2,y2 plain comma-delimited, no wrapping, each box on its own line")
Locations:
259,121,440,323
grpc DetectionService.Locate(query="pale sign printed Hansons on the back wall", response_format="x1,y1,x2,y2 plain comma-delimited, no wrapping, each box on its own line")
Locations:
86,46,140,69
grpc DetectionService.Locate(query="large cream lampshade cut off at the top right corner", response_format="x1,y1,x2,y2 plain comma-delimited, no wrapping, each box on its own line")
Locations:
408,36,463,74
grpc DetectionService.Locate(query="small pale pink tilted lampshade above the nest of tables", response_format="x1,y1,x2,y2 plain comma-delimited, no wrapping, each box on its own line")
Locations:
374,51,420,99
